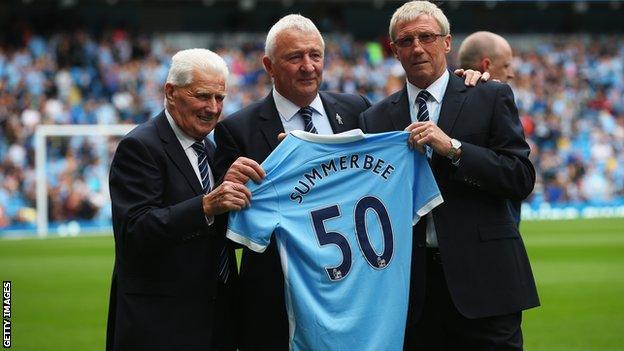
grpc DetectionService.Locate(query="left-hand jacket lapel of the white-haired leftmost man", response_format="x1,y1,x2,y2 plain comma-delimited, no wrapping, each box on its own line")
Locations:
155,111,203,195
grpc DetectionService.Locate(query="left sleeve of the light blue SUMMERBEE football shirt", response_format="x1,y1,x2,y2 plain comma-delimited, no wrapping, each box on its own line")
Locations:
226,180,279,252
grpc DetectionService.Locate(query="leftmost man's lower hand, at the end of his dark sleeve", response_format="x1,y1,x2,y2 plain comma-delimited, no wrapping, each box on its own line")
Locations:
202,181,251,217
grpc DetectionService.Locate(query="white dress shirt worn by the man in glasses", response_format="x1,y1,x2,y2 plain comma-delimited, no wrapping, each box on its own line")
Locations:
407,70,450,247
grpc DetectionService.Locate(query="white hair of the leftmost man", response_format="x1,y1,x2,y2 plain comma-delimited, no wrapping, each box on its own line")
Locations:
167,49,229,86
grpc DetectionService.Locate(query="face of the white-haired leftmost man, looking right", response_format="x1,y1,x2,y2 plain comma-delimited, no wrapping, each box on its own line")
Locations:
165,70,225,140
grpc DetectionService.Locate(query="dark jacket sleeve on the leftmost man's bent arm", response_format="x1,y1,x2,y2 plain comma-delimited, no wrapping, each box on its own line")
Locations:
110,139,207,248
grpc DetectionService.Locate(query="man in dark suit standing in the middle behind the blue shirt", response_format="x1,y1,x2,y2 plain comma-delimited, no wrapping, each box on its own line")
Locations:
215,15,370,350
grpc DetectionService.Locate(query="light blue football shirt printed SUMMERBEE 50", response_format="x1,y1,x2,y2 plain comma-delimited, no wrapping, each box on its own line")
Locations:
227,129,442,351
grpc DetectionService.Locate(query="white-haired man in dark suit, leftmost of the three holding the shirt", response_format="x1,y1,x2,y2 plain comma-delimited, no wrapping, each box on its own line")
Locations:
106,49,264,351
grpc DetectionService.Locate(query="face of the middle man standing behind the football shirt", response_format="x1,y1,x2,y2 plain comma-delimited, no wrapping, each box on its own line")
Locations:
262,29,323,107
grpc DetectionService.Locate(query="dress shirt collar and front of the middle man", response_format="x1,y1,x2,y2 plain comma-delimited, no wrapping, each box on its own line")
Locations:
273,88,334,135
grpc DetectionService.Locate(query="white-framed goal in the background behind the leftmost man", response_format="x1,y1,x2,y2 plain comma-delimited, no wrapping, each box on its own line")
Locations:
34,124,135,237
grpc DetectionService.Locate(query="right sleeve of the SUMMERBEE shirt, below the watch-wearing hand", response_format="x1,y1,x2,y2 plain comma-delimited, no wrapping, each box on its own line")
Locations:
412,151,444,225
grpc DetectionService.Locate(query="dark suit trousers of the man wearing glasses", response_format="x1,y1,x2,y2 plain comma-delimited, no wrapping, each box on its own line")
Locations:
405,249,522,351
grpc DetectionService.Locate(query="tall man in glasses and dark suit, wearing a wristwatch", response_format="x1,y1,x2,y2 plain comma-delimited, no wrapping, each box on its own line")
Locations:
361,1,539,350
